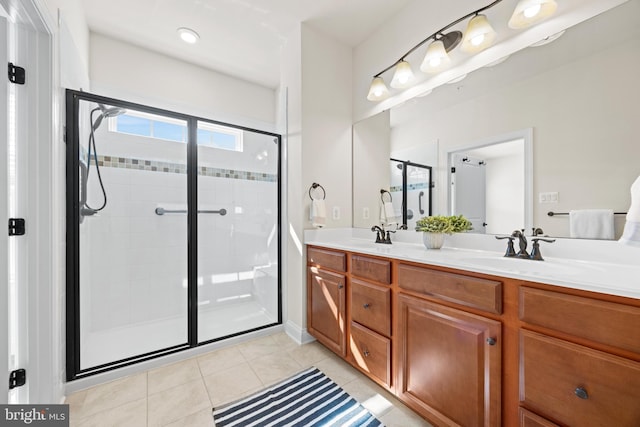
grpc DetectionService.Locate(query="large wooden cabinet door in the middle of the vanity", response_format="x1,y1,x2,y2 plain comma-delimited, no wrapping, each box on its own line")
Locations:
396,295,502,427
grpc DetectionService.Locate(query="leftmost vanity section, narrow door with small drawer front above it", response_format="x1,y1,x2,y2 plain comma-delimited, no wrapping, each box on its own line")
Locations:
307,248,347,357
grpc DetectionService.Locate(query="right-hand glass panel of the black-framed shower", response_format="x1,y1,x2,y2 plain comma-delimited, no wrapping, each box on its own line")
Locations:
197,121,280,343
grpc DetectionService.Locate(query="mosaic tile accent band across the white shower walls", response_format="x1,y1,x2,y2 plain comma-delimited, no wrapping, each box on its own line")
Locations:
98,155,278,182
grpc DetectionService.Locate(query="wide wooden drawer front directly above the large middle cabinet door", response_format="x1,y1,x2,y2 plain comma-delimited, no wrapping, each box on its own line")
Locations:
398,264,502,314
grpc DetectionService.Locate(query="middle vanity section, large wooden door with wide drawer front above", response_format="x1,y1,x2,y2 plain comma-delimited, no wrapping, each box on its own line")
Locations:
396,264,502,427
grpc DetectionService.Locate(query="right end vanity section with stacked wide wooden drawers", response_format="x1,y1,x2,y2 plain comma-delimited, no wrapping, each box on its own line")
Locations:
519,286,640,427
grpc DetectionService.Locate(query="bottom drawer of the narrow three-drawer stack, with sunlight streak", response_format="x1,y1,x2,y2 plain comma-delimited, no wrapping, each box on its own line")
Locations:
349,322,391,386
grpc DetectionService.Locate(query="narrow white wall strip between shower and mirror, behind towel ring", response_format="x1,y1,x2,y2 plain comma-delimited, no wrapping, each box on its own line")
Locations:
302,25,352,228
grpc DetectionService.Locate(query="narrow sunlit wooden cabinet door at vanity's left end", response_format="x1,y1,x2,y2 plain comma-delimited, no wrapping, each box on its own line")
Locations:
307,267,347,357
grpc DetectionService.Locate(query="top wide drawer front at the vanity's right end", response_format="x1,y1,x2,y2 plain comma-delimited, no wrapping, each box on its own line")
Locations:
520,287,640,353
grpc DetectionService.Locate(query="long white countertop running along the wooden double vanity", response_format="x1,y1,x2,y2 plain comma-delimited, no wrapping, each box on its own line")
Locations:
304,229,640,299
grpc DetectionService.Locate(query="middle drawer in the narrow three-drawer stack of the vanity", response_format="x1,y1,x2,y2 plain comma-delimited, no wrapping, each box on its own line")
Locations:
351,279,391,336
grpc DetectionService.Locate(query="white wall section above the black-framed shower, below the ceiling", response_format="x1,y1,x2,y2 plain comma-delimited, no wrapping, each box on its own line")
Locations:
89,33,276,131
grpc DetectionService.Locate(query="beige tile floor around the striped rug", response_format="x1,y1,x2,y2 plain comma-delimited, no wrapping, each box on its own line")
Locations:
66,333,430,427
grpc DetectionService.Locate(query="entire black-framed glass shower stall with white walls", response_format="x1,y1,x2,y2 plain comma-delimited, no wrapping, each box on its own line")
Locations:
66,90,282,380
